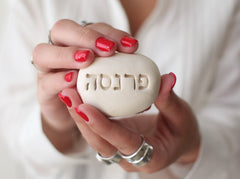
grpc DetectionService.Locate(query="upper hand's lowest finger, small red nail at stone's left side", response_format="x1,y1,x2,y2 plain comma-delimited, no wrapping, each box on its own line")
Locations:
38,70,78,103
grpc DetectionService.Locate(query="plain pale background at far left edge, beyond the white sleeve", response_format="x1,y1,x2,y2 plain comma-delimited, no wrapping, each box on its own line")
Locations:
0,0,28,179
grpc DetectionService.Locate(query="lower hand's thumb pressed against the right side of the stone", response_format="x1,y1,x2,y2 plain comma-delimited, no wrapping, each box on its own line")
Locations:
155,73,182,119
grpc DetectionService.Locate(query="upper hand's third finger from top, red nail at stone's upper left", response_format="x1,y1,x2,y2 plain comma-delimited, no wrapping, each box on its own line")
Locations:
33,44,94,72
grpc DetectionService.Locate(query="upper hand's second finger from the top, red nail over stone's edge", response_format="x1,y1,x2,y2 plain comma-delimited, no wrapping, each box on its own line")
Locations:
50,19,117,56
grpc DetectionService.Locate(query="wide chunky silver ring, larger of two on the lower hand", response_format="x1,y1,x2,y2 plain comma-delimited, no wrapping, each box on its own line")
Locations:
121,136,153,167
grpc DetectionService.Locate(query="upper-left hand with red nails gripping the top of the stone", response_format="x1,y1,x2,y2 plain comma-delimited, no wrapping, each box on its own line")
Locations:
33,20,138,153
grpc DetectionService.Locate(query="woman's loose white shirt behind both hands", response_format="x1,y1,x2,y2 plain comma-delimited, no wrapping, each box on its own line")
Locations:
0,0,240,179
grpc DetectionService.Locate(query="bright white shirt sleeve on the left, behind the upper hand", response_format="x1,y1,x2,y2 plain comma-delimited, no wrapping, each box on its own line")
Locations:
0,1,89,176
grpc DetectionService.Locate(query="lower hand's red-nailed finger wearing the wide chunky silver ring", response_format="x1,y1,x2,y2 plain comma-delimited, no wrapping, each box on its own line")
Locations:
75,104,169,172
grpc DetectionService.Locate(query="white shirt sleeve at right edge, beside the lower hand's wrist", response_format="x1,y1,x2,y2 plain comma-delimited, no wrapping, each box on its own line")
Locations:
185,3,240,179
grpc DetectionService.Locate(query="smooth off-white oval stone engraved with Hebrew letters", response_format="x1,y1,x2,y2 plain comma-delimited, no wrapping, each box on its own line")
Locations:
77,53,161,117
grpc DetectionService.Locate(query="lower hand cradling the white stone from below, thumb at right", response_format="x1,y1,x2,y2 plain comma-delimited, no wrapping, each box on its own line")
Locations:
63,73,200,173
